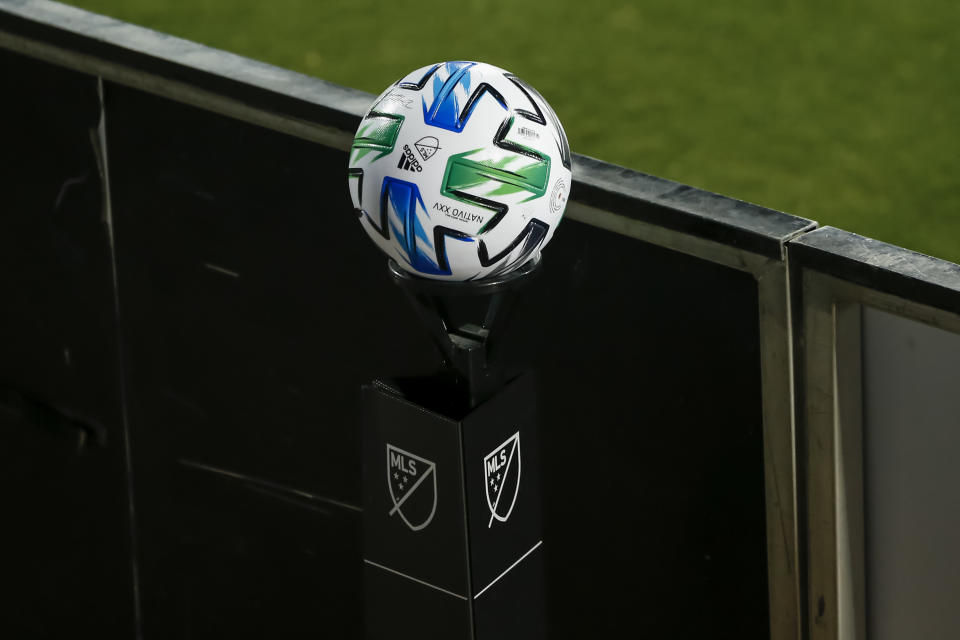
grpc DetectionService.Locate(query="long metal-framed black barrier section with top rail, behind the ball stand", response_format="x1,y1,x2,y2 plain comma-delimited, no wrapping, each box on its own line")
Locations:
0,1,960,640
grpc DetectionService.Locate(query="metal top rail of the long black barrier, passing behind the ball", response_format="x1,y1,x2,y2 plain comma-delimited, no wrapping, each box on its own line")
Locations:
0,0,816,260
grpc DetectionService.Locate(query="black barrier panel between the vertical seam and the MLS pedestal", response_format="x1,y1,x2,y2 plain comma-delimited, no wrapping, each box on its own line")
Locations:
106,85,432,638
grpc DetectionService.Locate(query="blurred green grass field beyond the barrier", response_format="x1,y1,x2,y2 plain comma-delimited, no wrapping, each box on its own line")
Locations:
71,0,960,262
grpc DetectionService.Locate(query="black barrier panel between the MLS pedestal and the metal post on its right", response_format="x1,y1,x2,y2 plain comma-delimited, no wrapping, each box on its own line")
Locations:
504,220,769,638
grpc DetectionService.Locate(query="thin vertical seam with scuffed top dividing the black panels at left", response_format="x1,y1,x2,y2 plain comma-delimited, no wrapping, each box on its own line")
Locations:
94,77,143,640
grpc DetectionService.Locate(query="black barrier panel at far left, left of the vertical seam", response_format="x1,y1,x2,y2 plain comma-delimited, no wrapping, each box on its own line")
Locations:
0,50,134,638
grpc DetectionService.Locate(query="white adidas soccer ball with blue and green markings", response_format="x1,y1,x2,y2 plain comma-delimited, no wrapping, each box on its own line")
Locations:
348,62,571,281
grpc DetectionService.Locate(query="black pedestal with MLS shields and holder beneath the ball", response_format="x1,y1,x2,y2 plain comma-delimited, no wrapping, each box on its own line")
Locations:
362,259,546,640
